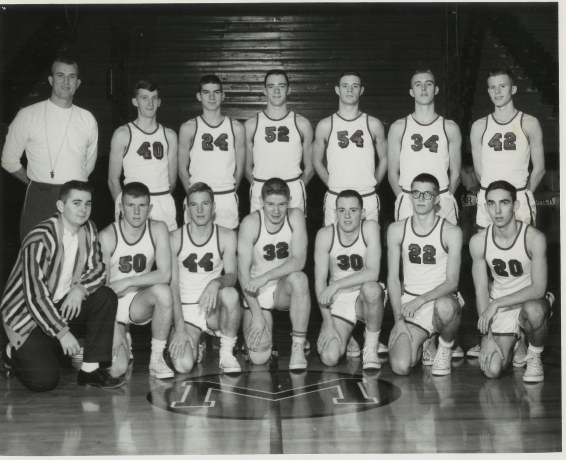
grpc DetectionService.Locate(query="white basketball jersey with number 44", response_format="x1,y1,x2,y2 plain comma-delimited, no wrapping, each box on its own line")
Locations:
177,224,224,304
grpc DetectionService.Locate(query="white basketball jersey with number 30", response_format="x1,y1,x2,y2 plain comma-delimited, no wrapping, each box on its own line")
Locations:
329,223,367,292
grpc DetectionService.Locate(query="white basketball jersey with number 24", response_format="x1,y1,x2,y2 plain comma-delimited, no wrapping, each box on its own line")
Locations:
189,116,236,192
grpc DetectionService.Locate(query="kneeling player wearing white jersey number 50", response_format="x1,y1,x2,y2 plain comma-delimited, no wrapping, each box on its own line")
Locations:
100,182,173,379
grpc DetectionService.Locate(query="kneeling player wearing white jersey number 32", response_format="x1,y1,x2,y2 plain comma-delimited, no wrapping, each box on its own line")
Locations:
238,178,311,370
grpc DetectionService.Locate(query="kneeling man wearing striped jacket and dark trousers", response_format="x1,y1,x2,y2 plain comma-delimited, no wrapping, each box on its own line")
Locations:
0,181,123,391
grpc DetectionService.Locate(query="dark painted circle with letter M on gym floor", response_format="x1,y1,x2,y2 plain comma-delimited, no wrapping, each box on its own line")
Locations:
147,369,401,420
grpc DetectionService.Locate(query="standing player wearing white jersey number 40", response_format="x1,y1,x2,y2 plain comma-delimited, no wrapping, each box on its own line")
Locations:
108,80,177,230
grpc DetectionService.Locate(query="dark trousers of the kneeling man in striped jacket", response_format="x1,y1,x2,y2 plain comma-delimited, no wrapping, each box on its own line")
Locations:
12,286,118,391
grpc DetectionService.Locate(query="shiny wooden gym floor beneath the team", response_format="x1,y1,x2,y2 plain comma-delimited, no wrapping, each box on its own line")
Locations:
0,328,562,456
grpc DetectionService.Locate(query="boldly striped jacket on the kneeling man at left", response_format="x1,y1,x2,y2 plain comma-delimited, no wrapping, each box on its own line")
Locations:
0,215,106,349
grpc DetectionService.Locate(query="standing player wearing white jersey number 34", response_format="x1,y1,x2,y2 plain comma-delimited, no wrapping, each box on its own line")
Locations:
387,70,462,225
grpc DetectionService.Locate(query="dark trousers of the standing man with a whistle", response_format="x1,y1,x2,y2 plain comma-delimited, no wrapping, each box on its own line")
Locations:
20,182,61,241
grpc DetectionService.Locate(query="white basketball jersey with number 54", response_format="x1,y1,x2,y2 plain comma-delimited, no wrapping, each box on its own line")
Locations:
326,113,377,195
